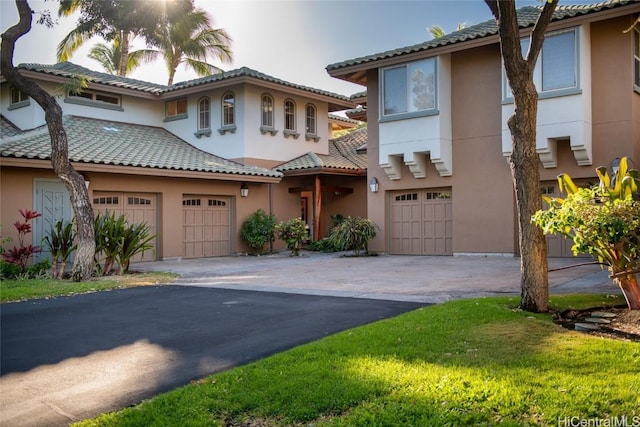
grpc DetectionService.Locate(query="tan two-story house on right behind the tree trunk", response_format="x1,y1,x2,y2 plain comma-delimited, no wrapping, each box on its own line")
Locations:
327,0,640,256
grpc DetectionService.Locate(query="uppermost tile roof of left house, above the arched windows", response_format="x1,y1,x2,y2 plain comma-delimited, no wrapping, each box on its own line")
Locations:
17,62,349,102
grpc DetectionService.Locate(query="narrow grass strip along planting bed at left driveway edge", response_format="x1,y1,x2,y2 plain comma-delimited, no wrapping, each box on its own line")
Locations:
0,273,178,303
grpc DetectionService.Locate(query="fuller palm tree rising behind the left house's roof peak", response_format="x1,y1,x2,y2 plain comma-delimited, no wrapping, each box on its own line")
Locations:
151,9,232,85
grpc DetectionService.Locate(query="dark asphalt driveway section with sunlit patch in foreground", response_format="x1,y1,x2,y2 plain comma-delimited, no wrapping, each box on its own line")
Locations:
0,285,424,426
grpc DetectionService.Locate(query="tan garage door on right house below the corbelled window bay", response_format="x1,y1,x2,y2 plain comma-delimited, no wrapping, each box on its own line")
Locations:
390,190,453,255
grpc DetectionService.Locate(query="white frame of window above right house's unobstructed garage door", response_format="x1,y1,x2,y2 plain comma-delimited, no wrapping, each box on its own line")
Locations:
379,57,438,121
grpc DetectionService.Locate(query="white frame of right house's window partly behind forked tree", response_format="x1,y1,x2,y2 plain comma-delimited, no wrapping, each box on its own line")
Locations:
502,27,581,103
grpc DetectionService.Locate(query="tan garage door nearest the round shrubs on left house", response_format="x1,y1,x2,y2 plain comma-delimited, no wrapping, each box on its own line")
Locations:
182,196,231,258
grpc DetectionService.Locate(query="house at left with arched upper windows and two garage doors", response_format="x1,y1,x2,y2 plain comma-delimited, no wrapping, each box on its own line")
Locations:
0,62,367,260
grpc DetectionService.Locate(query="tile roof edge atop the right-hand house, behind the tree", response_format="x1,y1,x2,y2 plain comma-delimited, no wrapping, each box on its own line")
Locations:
326,0,640,71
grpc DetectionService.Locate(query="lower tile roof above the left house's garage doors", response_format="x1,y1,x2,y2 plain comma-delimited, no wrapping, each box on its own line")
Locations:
0,116,282,178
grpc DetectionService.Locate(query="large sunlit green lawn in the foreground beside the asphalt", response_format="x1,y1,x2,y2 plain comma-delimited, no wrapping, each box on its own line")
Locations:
78,295,640,426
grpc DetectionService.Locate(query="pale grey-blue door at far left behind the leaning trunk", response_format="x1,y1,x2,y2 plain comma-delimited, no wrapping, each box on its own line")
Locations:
33,180,73,262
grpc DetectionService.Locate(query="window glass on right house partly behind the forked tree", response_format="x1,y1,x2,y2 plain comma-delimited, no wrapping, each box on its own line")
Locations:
503,28,579,99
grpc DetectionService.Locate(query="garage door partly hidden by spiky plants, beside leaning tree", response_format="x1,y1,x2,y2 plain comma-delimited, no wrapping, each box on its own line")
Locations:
93,191,158,262
